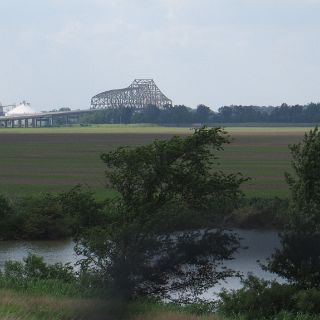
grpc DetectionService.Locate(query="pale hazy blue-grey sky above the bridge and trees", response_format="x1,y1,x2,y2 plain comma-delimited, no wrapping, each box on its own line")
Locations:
0,0,320,110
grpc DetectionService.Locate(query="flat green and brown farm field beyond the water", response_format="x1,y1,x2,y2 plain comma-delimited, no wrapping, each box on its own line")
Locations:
0,125,309,197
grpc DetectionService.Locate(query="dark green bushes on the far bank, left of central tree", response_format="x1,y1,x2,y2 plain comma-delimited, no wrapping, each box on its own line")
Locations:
0,186,102,240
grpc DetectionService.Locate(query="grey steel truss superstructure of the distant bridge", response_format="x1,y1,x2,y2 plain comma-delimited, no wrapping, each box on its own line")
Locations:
91,79,172,109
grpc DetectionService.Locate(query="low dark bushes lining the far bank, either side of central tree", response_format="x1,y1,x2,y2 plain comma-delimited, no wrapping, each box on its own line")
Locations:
0,186,289,240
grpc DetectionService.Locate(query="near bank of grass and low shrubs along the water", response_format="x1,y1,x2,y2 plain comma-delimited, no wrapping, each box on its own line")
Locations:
0,256,320,320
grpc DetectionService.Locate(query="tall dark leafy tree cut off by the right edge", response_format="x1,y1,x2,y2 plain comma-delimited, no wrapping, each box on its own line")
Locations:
266,127,320,288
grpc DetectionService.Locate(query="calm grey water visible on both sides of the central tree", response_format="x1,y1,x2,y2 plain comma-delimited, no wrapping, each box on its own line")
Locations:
0,230,280,293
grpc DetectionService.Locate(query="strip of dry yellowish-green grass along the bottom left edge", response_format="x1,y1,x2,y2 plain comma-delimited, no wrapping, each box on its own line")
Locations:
0,289,222,320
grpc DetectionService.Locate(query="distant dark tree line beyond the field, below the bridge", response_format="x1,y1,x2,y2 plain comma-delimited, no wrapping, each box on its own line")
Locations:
81,103,320,124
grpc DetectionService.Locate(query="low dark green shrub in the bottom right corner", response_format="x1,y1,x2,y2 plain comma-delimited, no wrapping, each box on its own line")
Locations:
218,275,320,320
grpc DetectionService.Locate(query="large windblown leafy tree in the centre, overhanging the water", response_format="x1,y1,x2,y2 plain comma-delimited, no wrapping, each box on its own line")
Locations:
76,128,246,298
